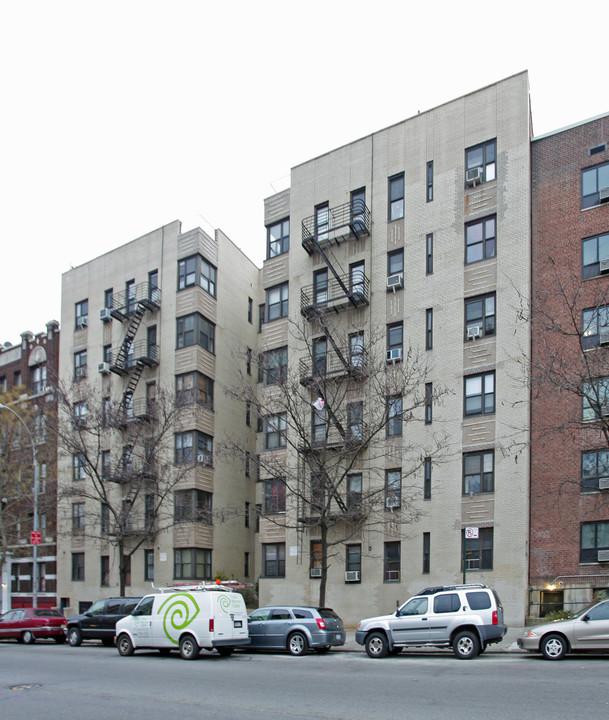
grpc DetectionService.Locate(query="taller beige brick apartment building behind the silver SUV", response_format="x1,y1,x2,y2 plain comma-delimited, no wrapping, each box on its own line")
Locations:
257,73,531,624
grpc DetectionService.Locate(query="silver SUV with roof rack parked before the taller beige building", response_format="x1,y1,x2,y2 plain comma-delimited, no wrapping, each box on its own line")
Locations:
355,584,507,660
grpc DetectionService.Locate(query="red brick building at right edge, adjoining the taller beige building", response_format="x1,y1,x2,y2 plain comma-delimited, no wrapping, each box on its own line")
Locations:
528,114,609,617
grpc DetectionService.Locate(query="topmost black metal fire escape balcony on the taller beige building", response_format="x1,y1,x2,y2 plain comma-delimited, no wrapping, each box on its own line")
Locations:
302,200,370,255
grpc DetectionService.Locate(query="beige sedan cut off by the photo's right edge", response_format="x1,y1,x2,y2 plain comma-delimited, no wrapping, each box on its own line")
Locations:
518,600,609,660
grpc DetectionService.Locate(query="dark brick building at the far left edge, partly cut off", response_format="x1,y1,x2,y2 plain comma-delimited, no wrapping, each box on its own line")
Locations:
0,320,60,612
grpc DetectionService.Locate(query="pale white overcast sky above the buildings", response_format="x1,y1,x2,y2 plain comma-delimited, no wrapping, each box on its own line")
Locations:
0,0,609,343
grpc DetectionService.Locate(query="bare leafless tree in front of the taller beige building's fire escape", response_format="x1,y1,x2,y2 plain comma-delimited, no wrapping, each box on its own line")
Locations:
224,318,445,605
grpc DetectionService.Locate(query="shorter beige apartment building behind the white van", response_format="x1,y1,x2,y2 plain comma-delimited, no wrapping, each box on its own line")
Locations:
57,221,260,611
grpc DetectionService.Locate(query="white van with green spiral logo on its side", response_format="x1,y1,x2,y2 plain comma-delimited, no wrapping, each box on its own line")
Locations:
115,585,250,660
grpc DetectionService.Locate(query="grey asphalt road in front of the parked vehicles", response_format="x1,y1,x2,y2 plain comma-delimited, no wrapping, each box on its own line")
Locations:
0,642,609,720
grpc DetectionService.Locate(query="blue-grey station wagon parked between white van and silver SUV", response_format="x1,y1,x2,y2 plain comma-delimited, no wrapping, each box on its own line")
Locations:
248,605,345,655
